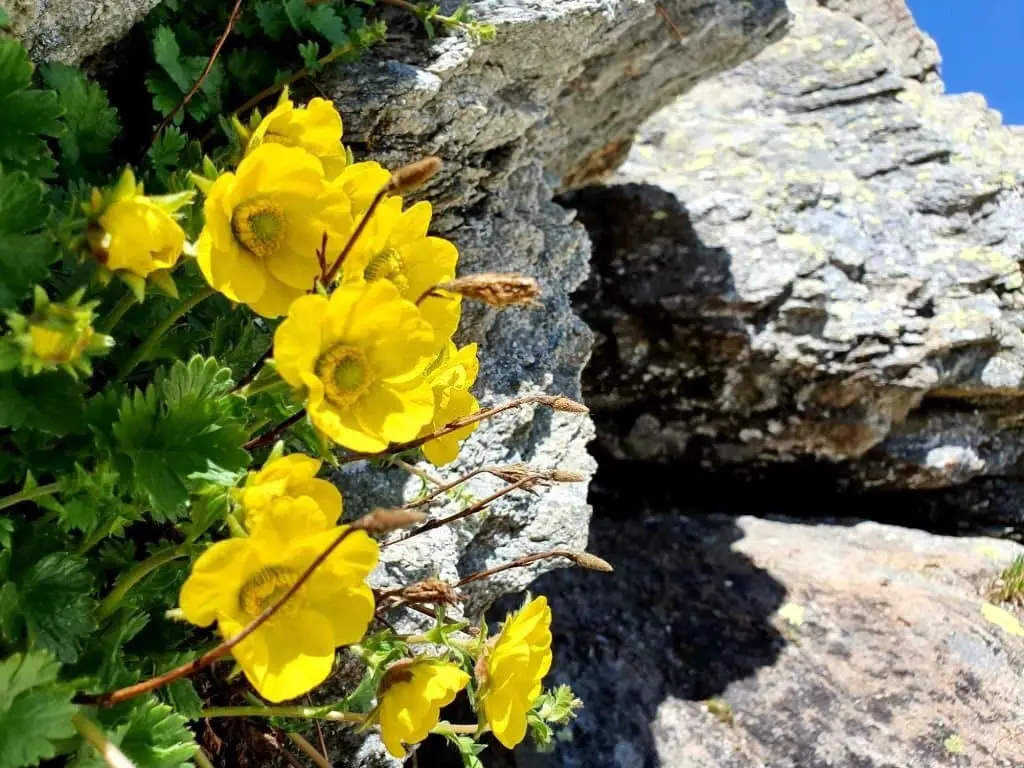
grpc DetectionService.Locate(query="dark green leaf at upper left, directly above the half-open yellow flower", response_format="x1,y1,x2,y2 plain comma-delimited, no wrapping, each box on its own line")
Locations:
42,63,121,178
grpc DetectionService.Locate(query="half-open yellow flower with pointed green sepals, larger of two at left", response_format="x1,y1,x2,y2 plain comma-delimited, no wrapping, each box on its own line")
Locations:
89,168,191,278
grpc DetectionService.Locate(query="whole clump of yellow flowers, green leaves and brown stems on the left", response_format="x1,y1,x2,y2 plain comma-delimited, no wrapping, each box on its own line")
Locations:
0,7,593,768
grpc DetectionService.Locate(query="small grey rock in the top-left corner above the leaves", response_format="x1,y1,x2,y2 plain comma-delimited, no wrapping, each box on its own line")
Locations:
9,0,160,63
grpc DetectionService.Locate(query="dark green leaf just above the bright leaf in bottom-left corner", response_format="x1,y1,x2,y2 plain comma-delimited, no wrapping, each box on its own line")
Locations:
14,552,96,664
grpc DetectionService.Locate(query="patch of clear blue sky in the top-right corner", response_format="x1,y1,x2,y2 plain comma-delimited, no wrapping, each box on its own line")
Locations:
907,0,1024,124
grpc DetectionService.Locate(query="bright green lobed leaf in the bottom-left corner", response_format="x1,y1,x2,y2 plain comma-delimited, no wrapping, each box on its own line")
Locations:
0,652,78,768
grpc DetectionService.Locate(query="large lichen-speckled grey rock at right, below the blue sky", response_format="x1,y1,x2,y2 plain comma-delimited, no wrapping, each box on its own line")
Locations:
567,0,1024,505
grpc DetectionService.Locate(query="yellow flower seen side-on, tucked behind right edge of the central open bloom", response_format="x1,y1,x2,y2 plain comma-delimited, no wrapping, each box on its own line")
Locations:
420,341,480,467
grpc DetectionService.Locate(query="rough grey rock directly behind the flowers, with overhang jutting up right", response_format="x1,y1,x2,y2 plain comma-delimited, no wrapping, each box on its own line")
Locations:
319,0,787,612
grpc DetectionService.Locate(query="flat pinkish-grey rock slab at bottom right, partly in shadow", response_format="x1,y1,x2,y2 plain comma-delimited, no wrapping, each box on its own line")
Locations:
518,499,1024,768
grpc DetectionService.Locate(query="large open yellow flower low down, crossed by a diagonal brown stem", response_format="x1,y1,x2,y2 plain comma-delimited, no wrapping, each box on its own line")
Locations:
179,497,378,701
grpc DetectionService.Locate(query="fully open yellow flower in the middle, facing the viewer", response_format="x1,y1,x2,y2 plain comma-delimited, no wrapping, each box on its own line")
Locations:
273,281,435,451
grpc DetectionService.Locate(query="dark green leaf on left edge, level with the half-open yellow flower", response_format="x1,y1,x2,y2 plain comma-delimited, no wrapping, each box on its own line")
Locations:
0,169,57,309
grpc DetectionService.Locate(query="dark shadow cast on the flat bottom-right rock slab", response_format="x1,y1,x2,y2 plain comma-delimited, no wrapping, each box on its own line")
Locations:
516,473,785,768
